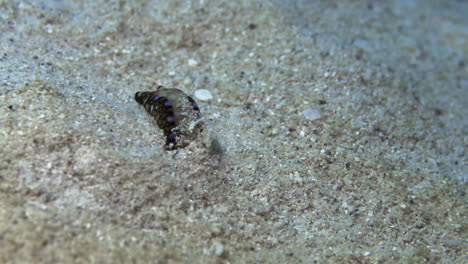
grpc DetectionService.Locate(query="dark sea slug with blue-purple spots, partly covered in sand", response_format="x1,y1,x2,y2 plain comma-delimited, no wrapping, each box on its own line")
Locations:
135,86,201,150
